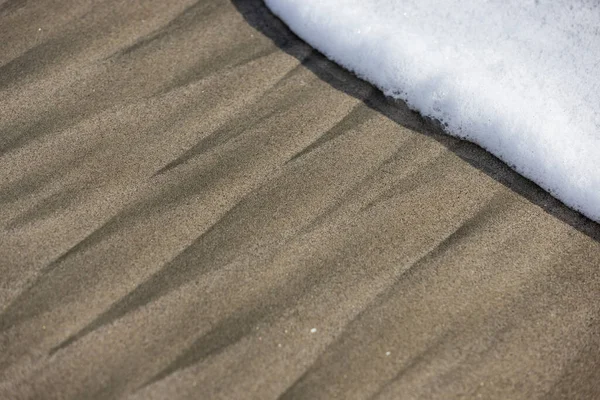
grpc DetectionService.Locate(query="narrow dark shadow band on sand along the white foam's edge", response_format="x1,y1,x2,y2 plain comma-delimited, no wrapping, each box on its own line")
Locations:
231,0,600,242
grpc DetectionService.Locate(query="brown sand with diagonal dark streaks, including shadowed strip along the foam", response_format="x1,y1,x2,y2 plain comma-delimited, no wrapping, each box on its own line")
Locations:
0,0,600,399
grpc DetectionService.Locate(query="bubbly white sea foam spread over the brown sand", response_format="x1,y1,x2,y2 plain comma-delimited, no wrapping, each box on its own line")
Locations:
266,0,600,221
